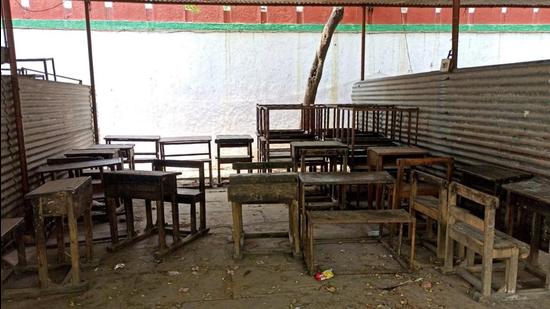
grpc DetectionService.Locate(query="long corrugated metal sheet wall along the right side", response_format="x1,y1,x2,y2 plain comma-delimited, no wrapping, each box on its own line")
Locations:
352,60,550,177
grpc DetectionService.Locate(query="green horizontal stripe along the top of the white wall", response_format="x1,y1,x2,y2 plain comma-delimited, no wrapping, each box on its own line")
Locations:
13,19,550,32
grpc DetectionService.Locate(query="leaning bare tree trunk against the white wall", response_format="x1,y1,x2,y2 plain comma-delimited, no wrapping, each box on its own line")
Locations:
303,7,344,130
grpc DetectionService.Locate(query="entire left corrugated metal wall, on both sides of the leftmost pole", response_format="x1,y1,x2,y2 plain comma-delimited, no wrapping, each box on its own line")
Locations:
2,77,94,217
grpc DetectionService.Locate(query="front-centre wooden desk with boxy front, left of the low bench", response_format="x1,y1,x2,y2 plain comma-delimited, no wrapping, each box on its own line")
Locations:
227,173,300,259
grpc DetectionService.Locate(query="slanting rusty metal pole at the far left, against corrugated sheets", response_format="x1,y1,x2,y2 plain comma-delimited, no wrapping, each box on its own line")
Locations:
2,0,33,231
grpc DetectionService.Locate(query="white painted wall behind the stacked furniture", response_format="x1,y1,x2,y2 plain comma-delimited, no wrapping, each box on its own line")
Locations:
9,29,550,166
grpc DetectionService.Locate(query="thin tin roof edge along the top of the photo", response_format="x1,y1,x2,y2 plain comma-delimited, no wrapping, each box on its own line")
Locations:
98,0,550,7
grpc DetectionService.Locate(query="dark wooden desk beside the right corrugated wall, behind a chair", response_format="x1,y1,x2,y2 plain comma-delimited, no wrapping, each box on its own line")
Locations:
367,146,429,209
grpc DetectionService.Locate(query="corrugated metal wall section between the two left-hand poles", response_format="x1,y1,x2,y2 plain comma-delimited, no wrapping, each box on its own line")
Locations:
19,78,94,189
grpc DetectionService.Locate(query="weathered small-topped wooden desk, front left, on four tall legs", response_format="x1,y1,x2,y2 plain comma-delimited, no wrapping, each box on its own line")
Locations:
25,177,93,288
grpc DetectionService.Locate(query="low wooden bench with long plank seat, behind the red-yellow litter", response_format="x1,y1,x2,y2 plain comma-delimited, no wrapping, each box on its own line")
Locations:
303,209,416,274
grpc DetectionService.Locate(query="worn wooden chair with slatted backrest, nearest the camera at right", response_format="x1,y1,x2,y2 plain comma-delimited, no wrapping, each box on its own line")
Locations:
443,182,529,300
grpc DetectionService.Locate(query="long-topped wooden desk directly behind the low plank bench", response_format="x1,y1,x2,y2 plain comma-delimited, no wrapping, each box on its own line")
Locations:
298,171,395,241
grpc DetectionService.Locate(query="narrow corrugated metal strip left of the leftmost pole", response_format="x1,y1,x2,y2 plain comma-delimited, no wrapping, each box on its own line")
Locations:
1,76,22,217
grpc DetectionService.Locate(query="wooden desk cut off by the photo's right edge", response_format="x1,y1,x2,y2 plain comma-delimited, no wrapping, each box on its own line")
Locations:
502,177,550,294
